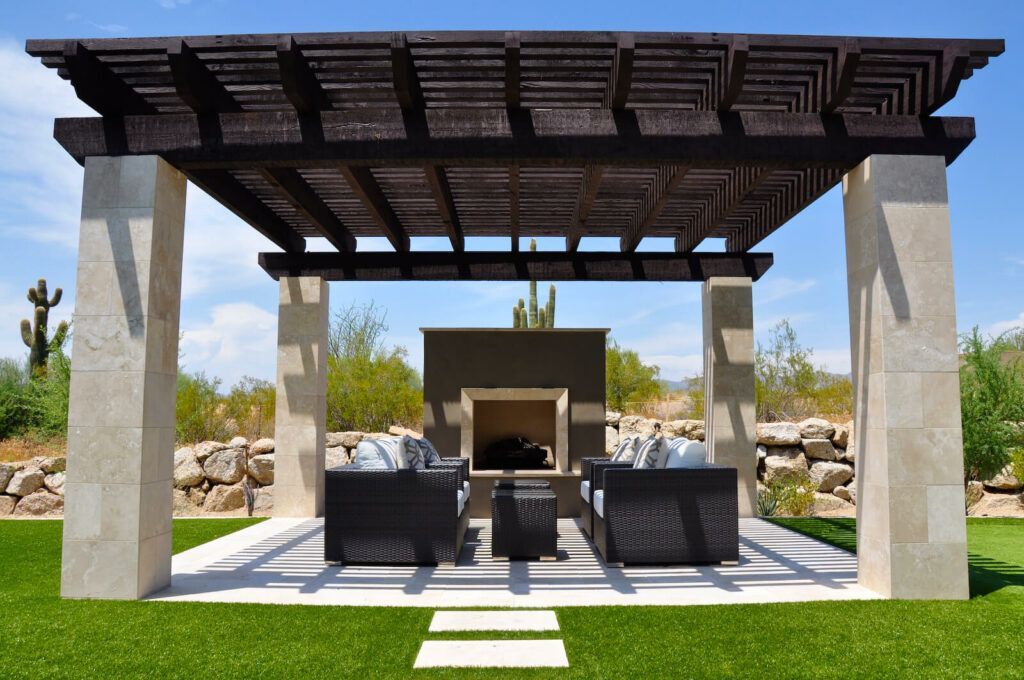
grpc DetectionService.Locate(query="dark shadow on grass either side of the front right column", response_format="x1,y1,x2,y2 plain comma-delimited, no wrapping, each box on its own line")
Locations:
767,517,1024,597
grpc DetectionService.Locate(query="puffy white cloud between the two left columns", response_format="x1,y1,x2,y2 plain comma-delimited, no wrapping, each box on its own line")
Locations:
180,302,278,387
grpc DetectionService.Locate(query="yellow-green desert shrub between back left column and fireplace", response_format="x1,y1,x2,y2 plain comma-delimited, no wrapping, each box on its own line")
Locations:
327,303,423,431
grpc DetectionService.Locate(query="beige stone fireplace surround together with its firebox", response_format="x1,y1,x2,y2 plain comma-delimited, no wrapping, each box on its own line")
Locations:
461,387,569,472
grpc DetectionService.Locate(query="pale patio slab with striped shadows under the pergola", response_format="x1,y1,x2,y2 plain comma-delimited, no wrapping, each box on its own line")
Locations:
150,518,878,609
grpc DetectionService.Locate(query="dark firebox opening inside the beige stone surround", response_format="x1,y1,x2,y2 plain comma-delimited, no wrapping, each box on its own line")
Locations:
473,399,557,470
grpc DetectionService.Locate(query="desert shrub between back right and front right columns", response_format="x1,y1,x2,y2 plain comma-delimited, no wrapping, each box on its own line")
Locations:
754,320,853,422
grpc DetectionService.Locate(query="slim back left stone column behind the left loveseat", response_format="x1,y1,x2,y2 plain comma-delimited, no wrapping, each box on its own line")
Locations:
273,277,329,517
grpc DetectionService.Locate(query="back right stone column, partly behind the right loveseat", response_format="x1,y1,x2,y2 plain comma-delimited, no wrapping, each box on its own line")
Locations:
702,277,758,517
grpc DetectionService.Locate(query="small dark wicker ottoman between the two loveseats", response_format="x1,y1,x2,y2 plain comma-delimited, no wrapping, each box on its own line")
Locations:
490,480,558,560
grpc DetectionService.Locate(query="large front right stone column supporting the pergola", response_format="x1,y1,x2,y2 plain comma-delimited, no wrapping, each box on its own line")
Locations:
843,156,968,599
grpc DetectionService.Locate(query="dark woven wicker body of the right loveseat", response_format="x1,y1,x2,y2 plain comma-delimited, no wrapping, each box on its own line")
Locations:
591,463,739,564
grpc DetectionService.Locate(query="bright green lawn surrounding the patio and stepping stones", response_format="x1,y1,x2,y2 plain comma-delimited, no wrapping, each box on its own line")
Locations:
0,519,1024,680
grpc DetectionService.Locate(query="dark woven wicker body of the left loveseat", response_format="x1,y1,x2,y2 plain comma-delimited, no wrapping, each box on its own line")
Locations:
324,458,469,564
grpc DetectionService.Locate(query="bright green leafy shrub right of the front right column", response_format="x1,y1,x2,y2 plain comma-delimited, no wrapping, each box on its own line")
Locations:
961,328,1024,479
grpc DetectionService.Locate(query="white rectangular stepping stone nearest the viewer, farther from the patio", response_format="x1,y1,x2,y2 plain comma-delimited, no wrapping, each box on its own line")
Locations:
413,640,569,668
